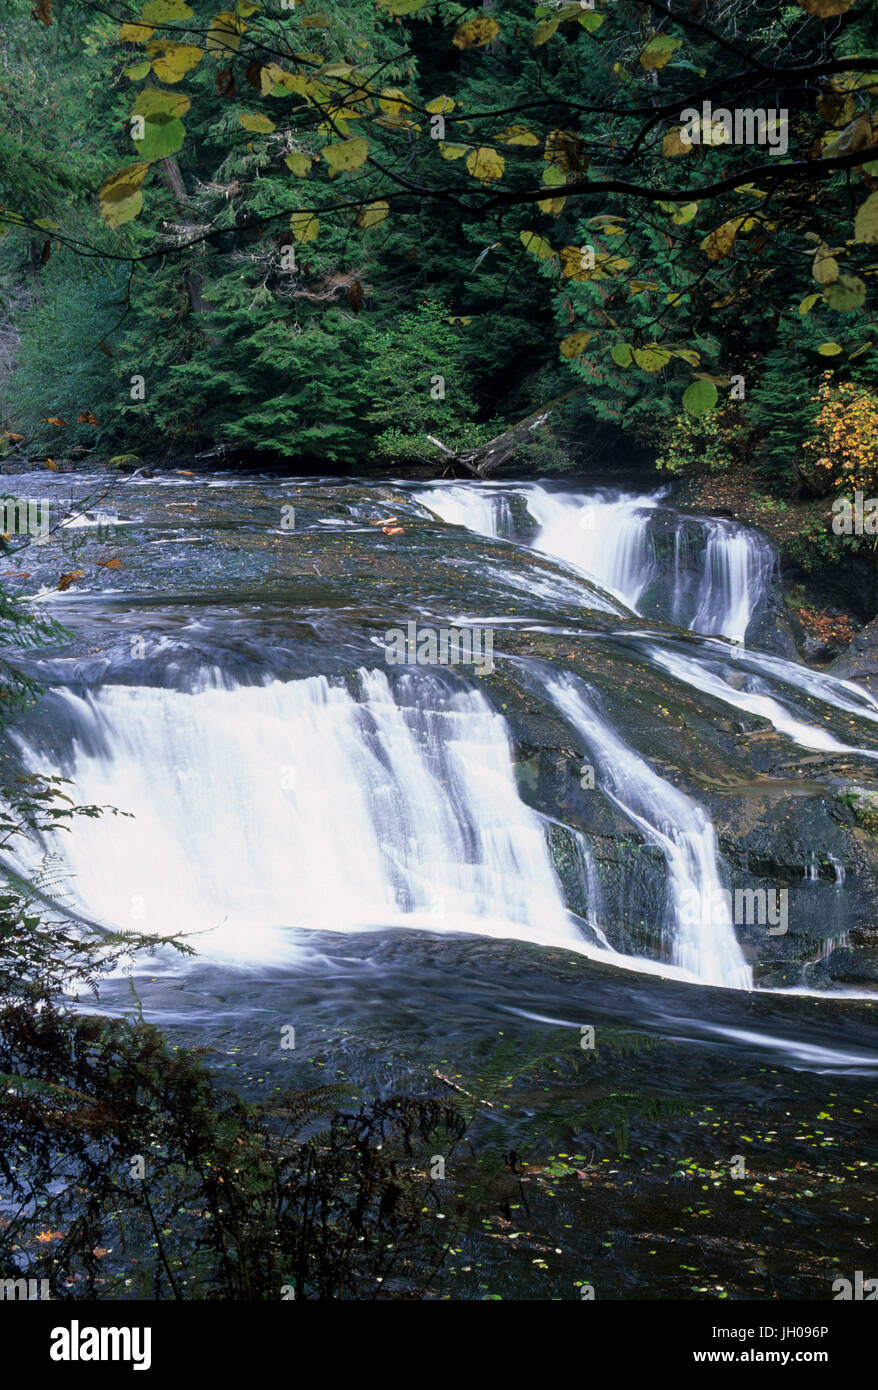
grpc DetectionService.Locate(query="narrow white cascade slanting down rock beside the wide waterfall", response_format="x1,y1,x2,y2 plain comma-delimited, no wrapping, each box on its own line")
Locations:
543,674,753,990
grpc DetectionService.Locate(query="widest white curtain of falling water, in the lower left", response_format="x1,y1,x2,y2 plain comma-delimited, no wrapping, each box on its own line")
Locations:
10,670,582,965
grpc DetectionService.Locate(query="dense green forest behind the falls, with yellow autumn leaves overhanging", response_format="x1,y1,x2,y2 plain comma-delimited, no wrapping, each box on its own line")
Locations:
0,0,878,496
